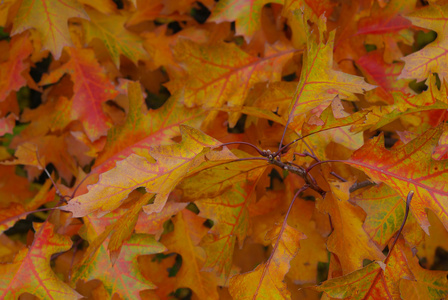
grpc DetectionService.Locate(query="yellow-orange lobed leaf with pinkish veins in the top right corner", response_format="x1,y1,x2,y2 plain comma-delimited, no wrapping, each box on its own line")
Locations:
398,4,448,81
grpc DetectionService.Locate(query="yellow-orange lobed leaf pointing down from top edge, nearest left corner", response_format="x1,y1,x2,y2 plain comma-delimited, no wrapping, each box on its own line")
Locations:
11,0,89,59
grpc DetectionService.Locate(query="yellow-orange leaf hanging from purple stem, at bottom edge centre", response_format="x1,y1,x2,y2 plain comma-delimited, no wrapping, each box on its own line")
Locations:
229,223,306,299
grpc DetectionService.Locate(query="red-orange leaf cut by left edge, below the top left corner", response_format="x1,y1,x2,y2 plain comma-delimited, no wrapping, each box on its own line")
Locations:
0,34,33,102
